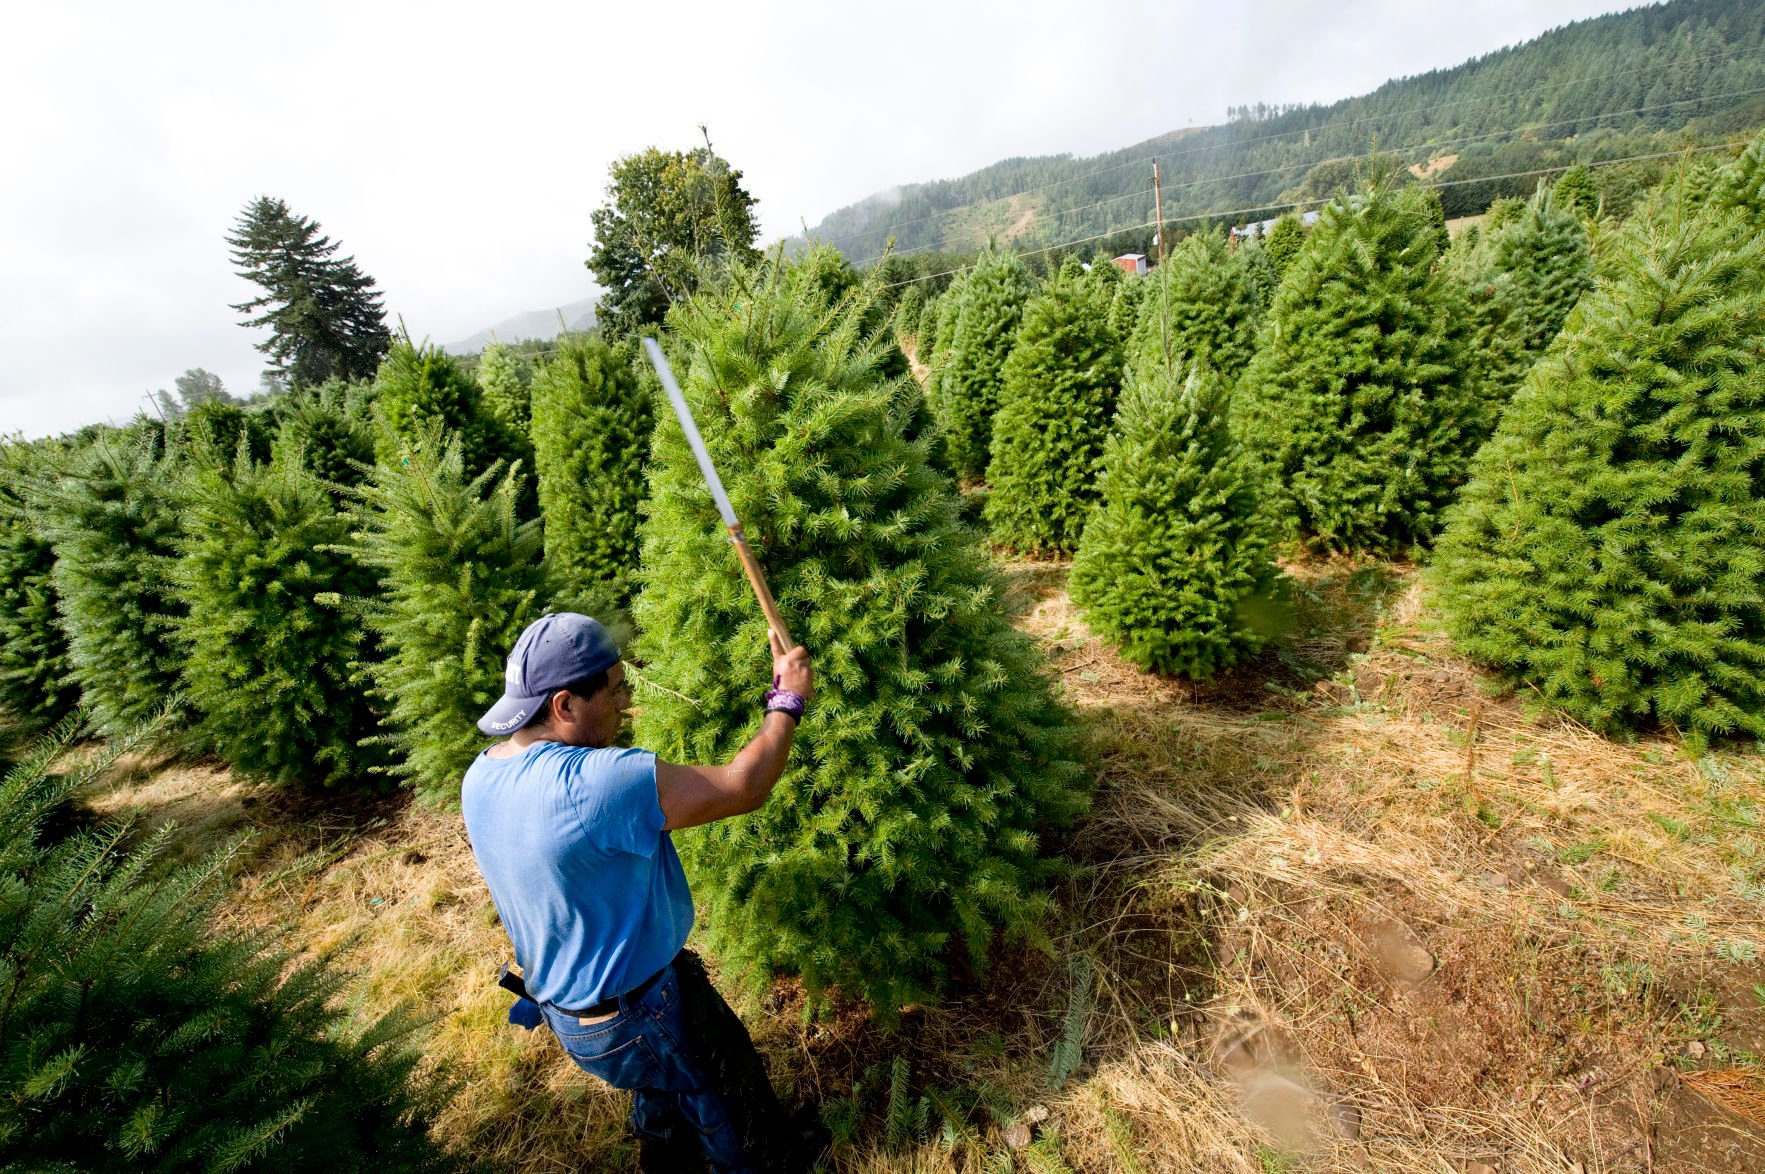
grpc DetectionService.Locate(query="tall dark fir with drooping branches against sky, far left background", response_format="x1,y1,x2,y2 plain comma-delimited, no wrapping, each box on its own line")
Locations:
226,196,392,385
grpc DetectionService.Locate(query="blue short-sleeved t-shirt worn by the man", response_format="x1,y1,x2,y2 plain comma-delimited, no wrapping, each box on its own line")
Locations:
461,741,692,1008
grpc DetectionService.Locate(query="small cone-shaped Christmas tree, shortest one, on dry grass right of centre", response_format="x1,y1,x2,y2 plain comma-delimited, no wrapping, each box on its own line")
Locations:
1068,367,1280,678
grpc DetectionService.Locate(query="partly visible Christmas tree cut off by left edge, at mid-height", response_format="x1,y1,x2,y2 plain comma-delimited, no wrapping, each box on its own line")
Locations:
0,443,79,733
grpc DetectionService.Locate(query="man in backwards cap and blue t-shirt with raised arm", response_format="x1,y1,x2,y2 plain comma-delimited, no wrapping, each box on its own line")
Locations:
461,613,819,1172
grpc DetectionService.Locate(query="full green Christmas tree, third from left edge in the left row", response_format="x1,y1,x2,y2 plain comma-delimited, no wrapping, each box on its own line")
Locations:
173,450,378,786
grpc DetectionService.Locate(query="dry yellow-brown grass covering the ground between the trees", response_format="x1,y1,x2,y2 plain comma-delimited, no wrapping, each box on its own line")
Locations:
75,561,1765,1174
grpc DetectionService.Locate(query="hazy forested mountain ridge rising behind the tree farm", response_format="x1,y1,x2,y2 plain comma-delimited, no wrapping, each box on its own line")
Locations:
810,0,1765,263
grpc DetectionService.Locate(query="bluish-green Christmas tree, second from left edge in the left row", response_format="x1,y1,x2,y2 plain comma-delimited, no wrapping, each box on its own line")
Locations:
37,427,184,734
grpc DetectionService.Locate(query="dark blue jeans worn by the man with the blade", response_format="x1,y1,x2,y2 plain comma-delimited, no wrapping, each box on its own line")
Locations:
542,952,784,1174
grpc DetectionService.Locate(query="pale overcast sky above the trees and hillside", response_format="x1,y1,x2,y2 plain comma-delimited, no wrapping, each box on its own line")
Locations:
0,0,1631,436
